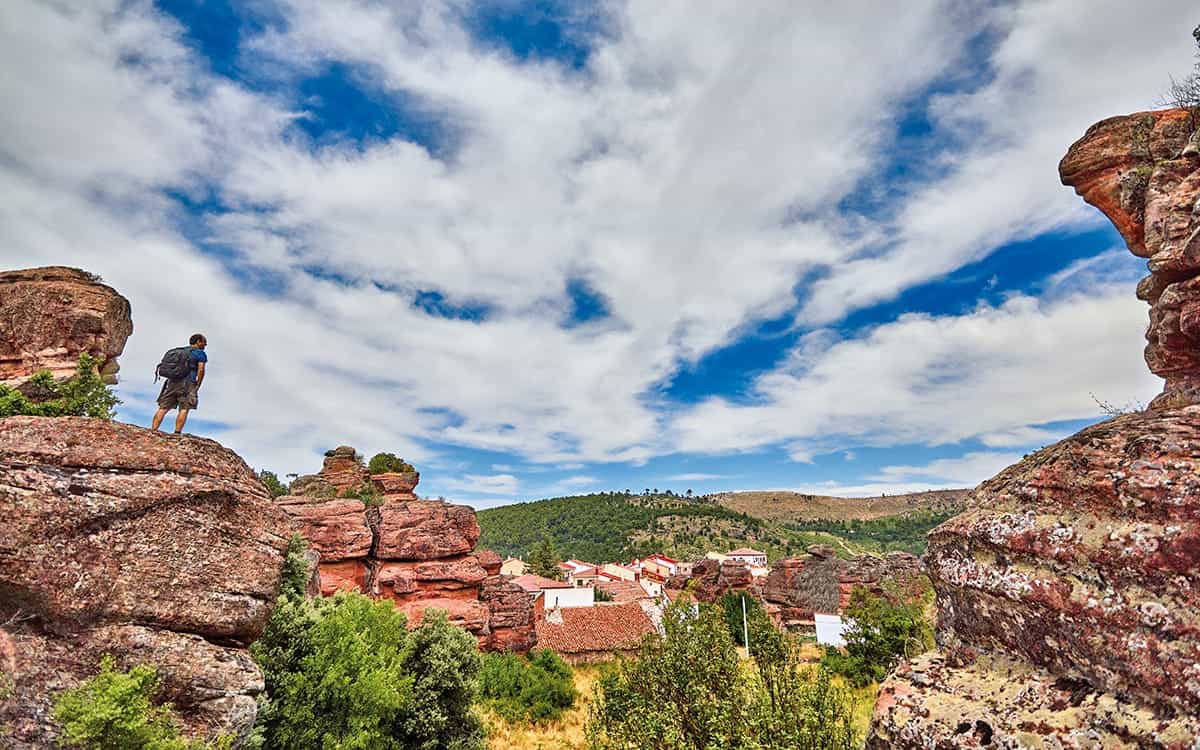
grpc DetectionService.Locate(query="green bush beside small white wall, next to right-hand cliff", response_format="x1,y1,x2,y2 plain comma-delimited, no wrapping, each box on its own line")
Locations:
821,587,934,688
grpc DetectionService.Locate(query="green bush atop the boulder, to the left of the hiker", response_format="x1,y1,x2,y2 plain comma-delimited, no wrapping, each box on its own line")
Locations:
0,354,121,419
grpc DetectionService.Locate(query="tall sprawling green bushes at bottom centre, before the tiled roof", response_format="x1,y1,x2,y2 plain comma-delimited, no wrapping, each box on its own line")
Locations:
587,602,858,750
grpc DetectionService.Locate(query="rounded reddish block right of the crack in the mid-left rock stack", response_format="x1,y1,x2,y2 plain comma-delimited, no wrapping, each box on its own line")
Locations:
376,500,480,560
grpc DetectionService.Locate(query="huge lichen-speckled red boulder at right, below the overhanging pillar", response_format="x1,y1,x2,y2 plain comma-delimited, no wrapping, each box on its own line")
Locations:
926,406,1200,714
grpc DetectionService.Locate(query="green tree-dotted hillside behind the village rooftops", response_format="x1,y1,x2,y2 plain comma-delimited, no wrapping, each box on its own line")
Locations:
478,492,956,562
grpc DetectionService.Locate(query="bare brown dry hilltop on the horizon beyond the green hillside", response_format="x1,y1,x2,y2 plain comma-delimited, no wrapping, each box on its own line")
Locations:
713,490,970,521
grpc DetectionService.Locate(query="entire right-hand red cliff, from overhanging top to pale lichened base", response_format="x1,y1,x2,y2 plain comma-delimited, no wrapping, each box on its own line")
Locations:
868,110,1200,750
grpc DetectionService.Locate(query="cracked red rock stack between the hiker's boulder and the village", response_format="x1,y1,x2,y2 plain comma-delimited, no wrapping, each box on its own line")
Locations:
277,446,535,652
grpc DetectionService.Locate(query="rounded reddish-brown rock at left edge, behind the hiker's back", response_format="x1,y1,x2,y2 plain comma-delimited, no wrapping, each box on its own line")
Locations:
0,266,133,385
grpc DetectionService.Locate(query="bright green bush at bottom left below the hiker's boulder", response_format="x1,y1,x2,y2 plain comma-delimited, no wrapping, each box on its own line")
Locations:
54,654,232,750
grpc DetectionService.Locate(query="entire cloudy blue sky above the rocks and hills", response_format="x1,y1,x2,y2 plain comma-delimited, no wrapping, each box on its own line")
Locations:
0,0,1196,506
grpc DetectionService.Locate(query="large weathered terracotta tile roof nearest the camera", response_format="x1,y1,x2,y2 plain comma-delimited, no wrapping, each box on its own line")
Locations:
538,601,655,654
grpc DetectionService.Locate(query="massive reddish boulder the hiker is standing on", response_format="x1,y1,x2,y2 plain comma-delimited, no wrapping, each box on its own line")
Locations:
0,416,292,748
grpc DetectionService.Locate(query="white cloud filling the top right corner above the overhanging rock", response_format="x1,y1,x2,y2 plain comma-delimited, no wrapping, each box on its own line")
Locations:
803,0,1195,323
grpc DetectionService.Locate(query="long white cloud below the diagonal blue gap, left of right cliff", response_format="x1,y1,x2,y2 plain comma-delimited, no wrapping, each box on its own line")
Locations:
673,287,1160,461
